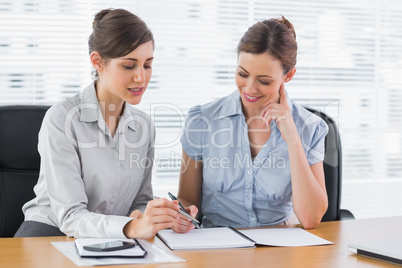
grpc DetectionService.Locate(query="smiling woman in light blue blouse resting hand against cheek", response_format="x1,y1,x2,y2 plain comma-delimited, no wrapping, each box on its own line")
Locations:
178,16,328,229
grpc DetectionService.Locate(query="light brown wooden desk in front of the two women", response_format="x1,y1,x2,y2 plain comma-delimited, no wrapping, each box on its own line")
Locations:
0,216,402,268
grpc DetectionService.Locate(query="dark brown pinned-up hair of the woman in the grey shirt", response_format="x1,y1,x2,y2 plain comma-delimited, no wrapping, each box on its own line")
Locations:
88,9,155,77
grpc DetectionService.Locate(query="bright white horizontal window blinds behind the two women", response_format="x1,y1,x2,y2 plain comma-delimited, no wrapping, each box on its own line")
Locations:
0,0,402,218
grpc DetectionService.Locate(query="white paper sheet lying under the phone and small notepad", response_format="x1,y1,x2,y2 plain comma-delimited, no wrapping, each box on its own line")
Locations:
52,239,185,266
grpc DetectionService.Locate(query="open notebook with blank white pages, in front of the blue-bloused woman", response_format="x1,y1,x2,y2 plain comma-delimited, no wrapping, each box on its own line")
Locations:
158,227,332,250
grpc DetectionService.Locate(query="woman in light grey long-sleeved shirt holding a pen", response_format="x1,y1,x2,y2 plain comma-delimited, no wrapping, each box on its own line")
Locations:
15,9,194,239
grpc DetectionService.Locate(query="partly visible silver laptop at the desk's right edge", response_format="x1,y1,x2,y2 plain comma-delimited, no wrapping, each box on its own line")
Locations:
348,238,402,264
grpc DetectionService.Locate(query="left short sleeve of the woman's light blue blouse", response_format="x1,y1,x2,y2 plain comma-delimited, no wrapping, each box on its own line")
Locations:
181,105,207,161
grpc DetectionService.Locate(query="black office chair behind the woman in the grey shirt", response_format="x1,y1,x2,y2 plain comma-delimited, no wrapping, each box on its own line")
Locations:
0,105,49,237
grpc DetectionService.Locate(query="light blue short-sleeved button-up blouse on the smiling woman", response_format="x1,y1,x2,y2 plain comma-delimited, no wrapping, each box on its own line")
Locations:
181,90,328,227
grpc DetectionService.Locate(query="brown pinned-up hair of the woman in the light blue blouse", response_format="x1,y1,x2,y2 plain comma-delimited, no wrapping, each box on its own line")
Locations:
237,16,297,74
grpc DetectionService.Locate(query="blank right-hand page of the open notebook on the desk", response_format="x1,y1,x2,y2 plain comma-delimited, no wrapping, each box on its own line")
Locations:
239,228,333,247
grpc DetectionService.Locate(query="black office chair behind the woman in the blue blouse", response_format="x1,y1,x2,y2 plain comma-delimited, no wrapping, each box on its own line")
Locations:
306,107,354,221
